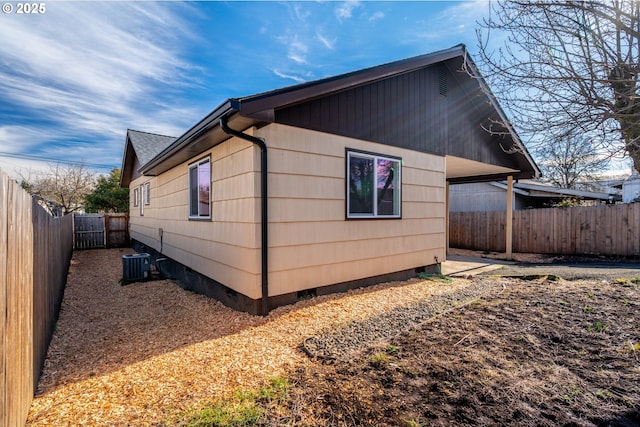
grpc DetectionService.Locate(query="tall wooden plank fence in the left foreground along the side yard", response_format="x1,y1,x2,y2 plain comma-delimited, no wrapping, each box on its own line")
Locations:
0,171,73,427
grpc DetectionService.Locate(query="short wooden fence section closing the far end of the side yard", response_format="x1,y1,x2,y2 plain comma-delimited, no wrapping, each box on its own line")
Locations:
73,213,129,249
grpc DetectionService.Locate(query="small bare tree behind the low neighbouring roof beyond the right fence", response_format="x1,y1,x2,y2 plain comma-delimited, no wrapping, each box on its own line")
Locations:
536,136,609,189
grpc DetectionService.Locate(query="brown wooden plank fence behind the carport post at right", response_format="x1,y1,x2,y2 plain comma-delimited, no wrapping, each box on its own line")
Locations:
449,203,640,257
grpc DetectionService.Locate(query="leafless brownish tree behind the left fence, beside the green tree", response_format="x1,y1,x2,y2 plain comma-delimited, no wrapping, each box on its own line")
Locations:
21,163,95,215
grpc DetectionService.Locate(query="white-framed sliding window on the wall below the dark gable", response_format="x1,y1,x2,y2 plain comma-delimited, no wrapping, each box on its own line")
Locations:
347,151,402,218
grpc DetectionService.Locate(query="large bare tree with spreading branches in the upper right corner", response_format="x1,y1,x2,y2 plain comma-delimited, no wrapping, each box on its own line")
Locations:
478,0,640,171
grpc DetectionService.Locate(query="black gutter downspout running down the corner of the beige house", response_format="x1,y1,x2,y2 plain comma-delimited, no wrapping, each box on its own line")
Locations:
220,114,269,316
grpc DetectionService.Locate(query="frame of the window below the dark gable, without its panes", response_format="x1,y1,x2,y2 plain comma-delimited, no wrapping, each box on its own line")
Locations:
345,148,402,220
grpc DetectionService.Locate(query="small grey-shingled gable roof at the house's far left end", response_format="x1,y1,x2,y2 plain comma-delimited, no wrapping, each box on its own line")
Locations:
120,129,176,186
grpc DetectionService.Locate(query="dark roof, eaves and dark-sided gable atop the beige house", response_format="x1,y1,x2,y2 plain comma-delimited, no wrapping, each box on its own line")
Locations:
123,45,540,185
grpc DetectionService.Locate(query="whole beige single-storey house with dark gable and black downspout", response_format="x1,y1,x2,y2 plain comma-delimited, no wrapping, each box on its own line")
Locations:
121,46,539,314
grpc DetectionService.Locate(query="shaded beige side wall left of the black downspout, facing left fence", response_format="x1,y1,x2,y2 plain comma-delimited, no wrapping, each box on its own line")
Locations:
130,138,261,299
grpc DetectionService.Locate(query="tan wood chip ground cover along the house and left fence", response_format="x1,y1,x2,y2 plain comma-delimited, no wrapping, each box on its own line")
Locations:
27,249,470,426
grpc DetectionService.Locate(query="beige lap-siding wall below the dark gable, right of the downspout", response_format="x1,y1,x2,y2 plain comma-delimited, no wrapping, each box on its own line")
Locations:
258,125,445,296
